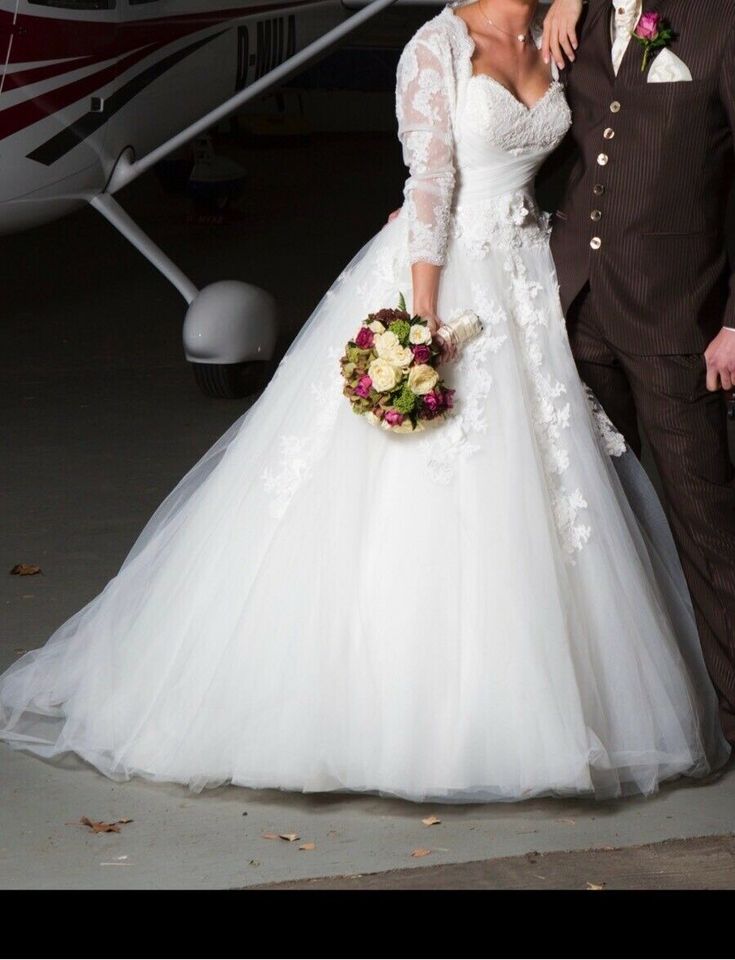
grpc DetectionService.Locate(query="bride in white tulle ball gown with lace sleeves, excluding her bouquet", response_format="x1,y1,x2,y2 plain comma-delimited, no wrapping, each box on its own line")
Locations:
0,0,727,801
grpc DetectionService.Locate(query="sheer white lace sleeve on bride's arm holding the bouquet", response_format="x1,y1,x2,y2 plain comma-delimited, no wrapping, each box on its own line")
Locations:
396,33,454,266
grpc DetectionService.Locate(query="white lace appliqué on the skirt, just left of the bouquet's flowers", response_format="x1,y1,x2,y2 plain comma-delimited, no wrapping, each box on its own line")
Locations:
261,350,342,519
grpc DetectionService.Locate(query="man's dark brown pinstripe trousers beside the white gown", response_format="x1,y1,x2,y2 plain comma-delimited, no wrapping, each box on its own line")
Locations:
567,284,735,744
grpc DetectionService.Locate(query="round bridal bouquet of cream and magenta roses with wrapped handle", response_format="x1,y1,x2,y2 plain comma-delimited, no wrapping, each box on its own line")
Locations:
340,296,482,433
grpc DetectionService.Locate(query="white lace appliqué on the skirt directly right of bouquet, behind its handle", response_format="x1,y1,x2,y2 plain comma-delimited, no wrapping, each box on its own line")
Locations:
424,283,508,484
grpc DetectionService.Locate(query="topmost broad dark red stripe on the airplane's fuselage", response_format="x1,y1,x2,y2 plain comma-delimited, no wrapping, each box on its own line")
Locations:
0,0,318,63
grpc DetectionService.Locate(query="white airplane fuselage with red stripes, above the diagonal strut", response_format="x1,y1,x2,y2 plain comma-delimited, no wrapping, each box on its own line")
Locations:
0,0,345,233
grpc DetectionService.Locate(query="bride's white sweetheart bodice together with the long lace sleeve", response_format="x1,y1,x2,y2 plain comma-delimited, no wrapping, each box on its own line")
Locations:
396,7,571,265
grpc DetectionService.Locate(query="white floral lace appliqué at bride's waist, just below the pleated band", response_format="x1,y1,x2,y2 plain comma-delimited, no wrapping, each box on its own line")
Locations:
452,190,551,260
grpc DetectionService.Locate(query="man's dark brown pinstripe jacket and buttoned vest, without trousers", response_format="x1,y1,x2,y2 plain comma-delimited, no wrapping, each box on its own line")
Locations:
552,0,735,355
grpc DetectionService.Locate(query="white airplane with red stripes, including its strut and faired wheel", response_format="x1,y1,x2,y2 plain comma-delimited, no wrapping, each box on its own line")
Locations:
0,0,420,397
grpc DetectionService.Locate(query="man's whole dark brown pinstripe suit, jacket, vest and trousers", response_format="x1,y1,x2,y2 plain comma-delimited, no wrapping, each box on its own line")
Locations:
552,0,735,742
